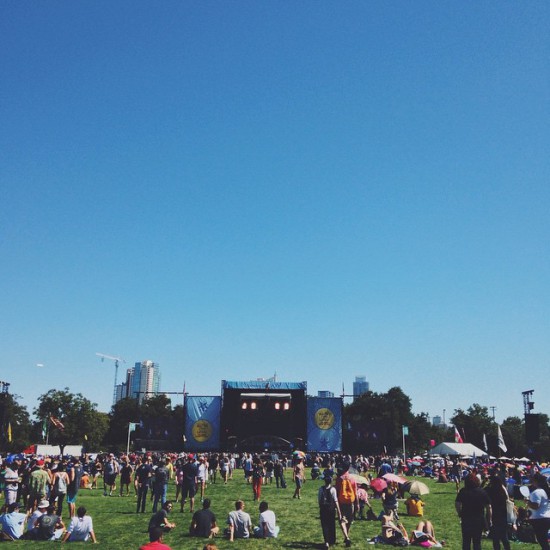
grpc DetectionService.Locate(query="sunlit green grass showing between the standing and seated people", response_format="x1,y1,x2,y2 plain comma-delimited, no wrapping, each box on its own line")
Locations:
12,470,539,550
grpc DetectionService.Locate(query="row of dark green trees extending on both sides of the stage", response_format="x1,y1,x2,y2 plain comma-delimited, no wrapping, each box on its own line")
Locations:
0,387,550,459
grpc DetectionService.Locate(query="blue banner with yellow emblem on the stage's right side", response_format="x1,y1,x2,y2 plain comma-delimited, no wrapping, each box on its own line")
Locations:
307,397,343,452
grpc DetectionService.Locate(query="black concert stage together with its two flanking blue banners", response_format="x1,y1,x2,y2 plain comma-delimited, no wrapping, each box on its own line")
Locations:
185,380,342,452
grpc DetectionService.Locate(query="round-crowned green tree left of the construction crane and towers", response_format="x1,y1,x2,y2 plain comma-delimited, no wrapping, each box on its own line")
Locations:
34,388,109,453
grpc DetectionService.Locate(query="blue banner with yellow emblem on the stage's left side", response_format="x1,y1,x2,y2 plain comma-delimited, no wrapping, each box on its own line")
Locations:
185,396,222,451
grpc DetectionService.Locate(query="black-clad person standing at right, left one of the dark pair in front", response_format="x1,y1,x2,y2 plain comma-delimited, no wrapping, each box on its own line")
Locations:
455,474,492,550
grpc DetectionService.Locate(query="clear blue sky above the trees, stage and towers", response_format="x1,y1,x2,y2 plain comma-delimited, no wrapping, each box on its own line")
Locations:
0,0,550,421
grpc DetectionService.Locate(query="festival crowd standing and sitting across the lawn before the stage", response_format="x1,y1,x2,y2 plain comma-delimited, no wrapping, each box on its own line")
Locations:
0,452,550,550
